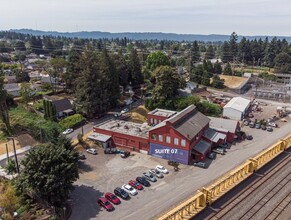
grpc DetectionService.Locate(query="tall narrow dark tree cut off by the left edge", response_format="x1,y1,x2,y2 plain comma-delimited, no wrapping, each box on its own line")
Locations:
0,74,11,134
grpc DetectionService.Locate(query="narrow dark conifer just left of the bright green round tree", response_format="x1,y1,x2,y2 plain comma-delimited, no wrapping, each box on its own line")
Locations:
128,49,144,85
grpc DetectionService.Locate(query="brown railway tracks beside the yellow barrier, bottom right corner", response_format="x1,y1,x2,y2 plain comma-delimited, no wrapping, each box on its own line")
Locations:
192,150,291,220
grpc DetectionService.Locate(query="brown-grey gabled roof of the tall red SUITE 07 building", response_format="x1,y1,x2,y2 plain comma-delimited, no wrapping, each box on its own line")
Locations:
169,105,210,140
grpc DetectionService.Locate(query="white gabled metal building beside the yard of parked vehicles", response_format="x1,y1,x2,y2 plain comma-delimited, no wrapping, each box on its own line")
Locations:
223,97,251,120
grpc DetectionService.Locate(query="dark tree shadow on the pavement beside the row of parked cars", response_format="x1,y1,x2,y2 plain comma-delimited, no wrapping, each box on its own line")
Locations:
69,185,103,220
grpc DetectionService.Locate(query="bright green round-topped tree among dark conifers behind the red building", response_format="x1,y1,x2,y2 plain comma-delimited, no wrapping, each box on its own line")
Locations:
145,51,170,71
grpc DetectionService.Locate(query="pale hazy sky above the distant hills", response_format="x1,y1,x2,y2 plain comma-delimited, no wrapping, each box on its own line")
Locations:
0,0,291,36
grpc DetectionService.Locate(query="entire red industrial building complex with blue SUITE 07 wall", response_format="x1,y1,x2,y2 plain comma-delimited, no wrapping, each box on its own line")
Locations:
88,105,240,164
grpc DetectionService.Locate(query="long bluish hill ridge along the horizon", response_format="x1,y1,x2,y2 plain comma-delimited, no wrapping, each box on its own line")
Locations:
10,29,291,43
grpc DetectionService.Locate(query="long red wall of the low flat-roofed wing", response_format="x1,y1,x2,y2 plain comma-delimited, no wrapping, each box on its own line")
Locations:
93,128,149,152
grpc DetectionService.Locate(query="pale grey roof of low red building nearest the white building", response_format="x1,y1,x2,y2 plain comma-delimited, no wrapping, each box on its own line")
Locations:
208,117,238,133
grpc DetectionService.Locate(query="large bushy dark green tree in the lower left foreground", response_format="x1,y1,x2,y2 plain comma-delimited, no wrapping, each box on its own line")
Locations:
16,136,79,208
